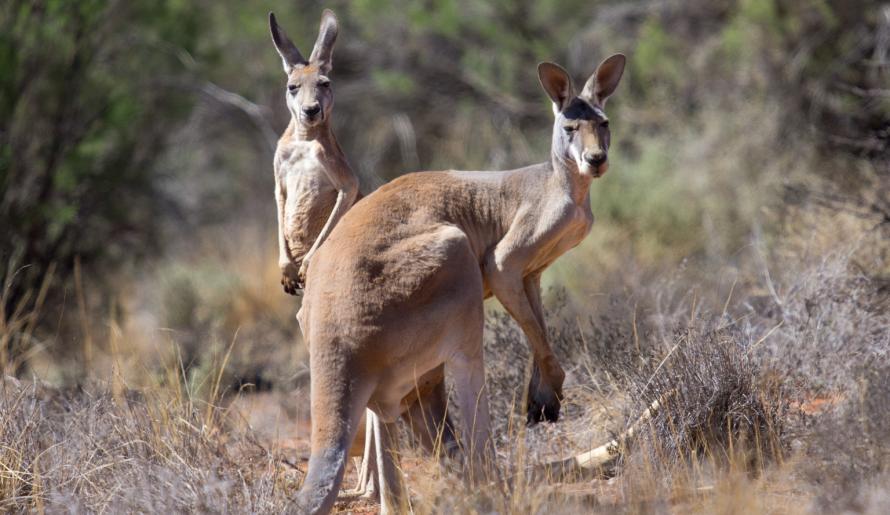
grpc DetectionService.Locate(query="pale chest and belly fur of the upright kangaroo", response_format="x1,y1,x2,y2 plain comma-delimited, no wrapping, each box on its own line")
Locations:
276,141,337,262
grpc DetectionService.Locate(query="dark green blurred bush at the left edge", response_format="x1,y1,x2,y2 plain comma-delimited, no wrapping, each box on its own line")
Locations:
0,0,205,360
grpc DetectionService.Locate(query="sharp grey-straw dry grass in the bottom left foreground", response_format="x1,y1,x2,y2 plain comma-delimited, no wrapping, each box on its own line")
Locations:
0,379,299,513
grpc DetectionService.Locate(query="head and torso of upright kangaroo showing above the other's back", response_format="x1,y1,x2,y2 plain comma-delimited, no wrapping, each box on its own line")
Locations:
269,9,358,295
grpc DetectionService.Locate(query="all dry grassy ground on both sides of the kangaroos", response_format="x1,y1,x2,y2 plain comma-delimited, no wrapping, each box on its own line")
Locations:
0,207,890,513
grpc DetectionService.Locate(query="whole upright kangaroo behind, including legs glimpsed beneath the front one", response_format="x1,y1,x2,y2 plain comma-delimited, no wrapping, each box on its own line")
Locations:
269,9,454,493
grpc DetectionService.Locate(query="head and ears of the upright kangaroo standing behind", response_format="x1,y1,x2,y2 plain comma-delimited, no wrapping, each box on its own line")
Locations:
269,9,337,127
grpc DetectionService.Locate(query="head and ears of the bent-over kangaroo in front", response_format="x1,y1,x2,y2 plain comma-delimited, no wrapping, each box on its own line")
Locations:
538,54,625,177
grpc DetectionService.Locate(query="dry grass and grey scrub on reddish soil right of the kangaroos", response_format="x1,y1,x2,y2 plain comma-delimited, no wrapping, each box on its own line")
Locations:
412,209,890,513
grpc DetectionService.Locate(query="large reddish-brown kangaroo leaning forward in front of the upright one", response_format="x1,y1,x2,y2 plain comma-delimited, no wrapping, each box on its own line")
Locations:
296,55,625,513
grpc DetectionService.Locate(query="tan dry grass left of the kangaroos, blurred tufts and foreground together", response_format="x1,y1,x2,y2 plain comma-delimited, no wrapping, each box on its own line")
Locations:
0,226,304,513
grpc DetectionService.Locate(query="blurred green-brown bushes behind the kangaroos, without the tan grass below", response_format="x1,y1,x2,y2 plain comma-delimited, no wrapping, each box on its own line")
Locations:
0,0,890,374
